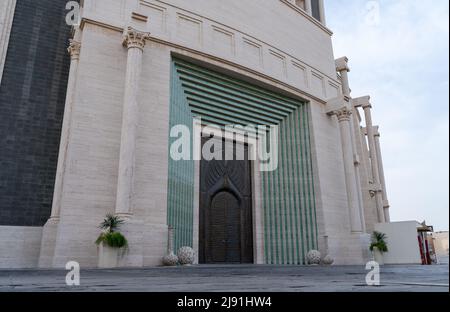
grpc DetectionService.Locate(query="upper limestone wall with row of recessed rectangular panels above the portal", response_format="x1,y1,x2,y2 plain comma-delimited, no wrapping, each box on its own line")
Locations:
83,0,340,100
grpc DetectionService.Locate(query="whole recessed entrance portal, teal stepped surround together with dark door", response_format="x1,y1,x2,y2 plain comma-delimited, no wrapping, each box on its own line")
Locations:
167,58,319,264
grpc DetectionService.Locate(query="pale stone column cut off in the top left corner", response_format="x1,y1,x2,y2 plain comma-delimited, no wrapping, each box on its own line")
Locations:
0,0,16,84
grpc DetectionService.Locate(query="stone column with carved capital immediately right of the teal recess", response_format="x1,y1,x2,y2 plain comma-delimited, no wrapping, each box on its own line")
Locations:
328,97,363,233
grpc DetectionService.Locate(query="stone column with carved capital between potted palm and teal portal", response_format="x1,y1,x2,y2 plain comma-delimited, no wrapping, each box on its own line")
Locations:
116,27,149,217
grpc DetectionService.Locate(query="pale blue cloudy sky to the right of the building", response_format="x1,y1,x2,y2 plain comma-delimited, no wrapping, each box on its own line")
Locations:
325,0,449,230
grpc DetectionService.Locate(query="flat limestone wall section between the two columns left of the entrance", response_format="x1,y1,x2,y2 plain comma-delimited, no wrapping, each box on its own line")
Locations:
53,25,126,266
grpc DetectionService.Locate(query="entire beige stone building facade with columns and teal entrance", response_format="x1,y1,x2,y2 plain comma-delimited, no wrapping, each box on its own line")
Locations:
0,0,389,267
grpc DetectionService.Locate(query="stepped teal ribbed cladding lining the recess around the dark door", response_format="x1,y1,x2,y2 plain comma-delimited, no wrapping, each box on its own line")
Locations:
168,59,318,264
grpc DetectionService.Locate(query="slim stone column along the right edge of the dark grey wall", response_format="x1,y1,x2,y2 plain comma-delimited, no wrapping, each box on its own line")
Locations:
50,40,81,220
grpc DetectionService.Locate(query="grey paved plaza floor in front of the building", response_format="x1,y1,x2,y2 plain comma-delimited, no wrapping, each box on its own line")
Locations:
0,263,449,292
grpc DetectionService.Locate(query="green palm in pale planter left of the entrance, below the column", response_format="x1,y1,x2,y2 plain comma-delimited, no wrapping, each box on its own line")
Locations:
95,214,128,268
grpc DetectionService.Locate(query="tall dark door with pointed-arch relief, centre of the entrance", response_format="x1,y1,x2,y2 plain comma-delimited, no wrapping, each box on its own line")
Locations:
199,140,253,263
